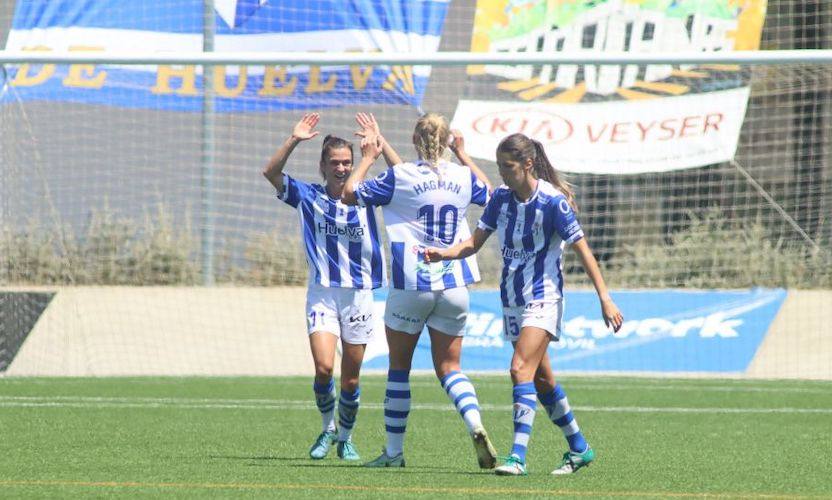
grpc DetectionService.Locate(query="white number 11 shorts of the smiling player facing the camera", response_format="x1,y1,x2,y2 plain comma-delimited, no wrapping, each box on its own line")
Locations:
306,284,373,344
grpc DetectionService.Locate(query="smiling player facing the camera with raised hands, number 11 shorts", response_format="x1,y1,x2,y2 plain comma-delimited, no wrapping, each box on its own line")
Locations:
263,113,399,460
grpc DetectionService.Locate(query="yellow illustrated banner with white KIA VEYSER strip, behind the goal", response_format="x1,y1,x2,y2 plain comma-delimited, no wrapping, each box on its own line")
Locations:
452,0,766,174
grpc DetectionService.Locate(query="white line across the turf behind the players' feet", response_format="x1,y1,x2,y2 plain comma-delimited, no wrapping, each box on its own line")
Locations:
0,396,832,414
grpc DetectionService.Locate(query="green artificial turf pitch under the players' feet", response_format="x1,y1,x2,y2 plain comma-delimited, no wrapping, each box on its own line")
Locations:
0,375,832,498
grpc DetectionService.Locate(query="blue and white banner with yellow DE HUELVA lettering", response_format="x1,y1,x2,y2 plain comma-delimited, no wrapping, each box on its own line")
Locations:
2,0,448,112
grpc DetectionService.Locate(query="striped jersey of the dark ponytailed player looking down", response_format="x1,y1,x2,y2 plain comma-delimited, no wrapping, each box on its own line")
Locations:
477,180,584,307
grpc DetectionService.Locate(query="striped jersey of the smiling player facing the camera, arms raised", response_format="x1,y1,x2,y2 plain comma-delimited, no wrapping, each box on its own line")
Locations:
277,173,386,289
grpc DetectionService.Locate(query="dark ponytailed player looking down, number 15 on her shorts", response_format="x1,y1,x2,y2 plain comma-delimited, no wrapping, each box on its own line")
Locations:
425,134,624,475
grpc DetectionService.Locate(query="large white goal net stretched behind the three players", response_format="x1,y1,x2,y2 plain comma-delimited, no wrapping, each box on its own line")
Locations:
0,0,832,377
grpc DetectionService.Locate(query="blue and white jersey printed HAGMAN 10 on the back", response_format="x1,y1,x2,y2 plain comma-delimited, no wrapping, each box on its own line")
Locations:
355,162,488,290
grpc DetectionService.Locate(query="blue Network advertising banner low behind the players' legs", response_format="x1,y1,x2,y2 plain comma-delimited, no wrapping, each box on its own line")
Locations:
364,289,786,373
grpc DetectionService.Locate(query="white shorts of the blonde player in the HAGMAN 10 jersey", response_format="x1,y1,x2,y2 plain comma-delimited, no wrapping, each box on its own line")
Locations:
384,286,469,337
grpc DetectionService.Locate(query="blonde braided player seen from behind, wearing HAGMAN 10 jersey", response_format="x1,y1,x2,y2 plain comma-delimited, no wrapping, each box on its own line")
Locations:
343,113,496,468
